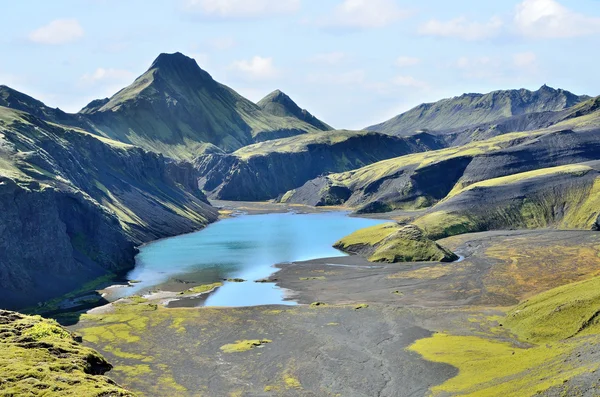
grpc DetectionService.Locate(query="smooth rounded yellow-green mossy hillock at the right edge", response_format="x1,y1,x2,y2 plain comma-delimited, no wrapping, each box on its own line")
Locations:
506,277,600,343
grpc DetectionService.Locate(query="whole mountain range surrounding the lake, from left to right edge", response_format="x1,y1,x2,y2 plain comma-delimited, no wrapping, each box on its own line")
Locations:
0,53,600,308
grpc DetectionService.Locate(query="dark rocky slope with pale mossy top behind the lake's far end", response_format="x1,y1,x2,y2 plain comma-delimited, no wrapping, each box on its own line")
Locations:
195,131,442,200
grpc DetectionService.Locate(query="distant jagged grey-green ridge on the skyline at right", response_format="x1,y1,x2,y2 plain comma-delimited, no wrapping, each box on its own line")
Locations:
366,85,590,136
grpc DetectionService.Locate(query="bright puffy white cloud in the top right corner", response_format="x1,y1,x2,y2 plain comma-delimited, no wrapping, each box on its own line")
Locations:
514,0,600,38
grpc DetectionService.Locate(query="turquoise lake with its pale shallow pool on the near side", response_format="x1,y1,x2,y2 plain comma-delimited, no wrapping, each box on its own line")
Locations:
113,212,383,306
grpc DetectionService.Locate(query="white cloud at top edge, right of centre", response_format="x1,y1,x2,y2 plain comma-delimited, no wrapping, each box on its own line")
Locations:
321,0,411,29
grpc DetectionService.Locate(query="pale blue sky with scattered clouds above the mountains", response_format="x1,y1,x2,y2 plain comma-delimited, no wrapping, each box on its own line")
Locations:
0,0,600,129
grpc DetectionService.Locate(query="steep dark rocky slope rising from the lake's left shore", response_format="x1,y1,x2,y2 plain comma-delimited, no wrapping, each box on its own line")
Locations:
0,107,217,308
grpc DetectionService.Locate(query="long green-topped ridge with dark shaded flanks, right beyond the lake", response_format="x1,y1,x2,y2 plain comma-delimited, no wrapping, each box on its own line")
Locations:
284,98,600,212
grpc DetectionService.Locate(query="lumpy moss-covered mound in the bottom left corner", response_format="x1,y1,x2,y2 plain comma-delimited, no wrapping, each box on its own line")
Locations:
0,311,133,397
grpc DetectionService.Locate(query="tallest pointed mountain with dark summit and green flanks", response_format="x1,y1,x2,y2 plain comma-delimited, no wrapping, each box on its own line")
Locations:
80,53,330,159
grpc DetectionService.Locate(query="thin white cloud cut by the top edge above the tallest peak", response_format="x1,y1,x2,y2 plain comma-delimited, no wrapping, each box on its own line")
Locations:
184,0,300,19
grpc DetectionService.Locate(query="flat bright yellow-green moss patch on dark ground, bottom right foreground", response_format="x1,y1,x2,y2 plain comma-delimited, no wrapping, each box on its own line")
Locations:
409,333,584,397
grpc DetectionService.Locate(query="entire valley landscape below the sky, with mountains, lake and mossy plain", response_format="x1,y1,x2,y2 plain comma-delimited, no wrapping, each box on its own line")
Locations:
0,53,600,397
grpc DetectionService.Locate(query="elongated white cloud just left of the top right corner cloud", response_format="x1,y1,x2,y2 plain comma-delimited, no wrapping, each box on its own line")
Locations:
419,17,504,41
